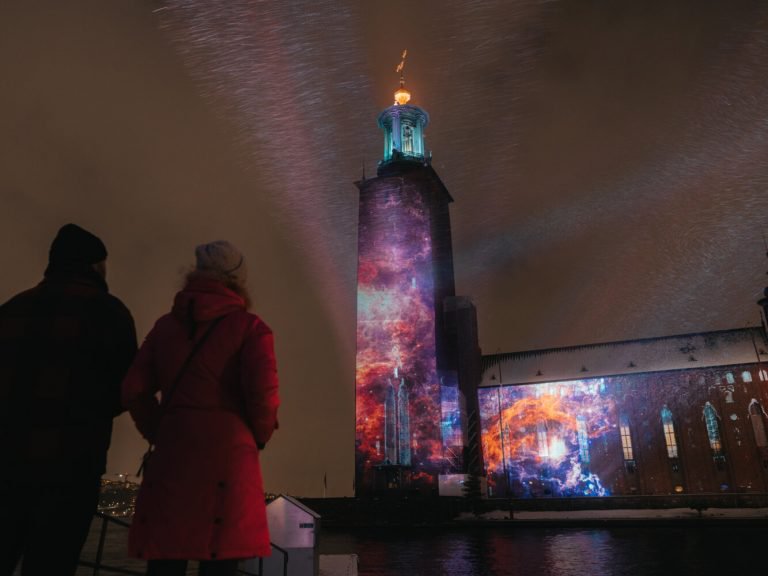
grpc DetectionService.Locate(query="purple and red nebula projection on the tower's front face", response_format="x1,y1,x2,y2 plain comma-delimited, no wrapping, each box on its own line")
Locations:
356,178,443,483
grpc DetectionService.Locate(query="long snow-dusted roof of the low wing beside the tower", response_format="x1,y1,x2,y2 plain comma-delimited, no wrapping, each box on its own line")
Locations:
480,327,768,386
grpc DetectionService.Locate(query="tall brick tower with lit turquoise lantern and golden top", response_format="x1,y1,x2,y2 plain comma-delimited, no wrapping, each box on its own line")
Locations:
355,58,474,496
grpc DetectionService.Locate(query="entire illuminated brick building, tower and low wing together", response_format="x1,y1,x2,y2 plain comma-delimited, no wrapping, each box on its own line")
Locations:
355,71,768,497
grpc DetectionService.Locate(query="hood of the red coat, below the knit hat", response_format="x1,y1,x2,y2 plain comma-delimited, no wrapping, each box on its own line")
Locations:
171,278,245,324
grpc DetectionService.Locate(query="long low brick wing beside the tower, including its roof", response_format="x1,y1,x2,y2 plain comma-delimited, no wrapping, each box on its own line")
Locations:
478,327,768,498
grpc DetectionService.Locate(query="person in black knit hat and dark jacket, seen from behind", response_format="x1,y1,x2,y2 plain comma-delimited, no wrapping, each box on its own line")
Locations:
0,224,136,576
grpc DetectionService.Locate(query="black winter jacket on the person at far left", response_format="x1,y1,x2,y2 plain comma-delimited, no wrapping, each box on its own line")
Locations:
0,270,136,484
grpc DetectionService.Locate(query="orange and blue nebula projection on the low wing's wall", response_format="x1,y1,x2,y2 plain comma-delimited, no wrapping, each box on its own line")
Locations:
478,379,618,497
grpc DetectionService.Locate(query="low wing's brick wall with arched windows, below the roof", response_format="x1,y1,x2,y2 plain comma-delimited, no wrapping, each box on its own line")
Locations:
478,364,768,498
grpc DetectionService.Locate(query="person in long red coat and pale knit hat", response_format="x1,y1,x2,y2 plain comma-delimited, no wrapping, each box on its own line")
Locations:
122,241,279,575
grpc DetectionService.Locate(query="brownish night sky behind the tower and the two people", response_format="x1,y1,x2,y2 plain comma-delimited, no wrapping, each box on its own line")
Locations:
0,0,768,495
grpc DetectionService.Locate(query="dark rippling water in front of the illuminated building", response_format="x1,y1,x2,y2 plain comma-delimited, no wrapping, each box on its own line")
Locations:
321,524,768,576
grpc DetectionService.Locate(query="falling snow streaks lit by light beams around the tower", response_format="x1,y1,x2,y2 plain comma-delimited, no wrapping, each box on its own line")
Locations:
154,0,768,360
